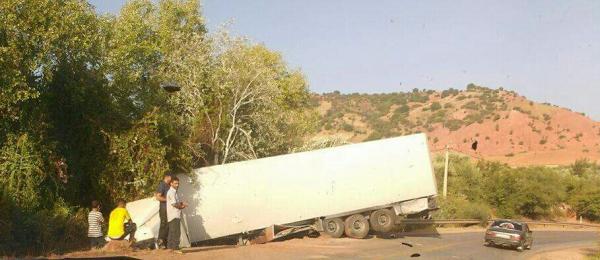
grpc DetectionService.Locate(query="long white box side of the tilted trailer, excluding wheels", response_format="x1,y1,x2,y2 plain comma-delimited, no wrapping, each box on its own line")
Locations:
180,134,436,242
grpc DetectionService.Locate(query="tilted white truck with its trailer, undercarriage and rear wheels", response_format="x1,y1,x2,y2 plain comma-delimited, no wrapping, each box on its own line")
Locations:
127,134,437,245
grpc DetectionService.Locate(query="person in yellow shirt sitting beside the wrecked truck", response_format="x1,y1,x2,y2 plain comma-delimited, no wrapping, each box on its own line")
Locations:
108,199,137,244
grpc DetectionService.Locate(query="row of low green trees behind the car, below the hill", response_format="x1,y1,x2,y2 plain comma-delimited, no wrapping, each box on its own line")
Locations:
434,155,600,221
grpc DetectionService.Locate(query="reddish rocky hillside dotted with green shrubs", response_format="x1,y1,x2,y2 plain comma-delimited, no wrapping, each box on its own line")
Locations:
313,84,600,165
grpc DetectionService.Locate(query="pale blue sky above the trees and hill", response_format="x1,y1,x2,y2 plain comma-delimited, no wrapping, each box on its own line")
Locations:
90,0,600,120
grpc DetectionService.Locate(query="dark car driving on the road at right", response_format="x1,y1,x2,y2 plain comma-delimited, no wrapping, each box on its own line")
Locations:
485,219,533,251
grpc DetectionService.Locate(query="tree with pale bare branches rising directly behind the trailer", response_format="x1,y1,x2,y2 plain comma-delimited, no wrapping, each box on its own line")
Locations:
165,31,311,165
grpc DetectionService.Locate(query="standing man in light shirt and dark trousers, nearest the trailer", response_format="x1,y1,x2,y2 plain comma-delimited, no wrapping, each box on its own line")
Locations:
167,177,187,250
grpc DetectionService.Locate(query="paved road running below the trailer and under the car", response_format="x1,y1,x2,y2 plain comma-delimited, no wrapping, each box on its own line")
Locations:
176,231,600,259
